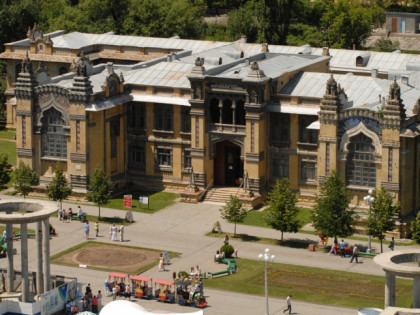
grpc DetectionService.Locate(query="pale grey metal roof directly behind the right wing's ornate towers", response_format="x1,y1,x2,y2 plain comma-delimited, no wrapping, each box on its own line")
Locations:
280,72,420,116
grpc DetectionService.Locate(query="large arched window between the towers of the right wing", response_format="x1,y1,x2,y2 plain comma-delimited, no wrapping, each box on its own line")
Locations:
346,133,376,187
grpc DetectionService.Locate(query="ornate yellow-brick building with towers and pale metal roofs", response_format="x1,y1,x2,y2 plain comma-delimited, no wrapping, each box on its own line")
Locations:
0,27,420,227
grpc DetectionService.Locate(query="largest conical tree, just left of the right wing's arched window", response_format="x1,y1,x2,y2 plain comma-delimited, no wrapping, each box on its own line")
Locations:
312,171,355,238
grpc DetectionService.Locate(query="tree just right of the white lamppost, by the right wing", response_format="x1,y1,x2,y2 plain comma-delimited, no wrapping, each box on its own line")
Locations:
367,186,401,253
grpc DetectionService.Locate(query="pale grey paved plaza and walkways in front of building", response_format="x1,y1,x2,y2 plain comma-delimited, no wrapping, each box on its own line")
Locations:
0,195,418,315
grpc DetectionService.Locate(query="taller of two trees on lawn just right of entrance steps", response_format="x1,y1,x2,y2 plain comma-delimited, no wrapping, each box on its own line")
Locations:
266,178,301,240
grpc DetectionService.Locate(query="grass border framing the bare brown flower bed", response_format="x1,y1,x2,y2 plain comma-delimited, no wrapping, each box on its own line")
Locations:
50,241,181,274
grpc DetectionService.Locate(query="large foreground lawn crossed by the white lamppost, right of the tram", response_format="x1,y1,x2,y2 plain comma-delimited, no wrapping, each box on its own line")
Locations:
203,259,413,308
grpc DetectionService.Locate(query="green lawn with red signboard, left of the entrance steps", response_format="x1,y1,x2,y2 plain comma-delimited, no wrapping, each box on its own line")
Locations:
105,190,179,213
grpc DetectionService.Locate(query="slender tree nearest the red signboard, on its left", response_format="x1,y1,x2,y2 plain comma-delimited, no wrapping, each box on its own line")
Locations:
86,166,112,219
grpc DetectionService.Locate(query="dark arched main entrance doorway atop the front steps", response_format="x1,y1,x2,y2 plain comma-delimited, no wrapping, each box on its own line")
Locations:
214,140,244,186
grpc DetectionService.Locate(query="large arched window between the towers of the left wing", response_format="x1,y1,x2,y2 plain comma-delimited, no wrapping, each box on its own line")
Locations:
41,107,67,158
